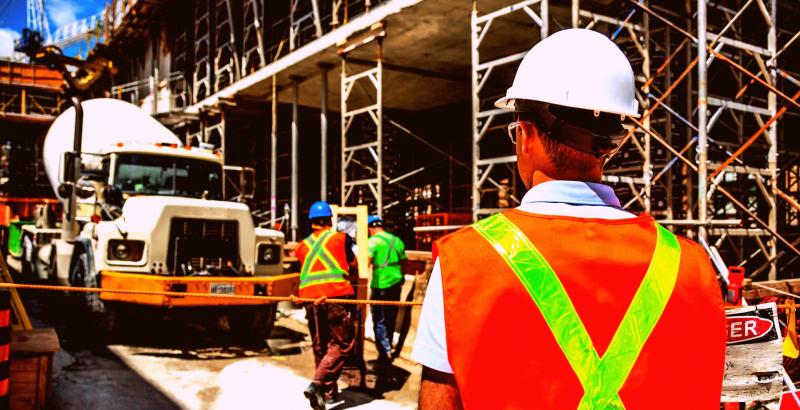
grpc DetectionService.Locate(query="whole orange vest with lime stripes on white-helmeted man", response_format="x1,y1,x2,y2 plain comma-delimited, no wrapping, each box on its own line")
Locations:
437,210,725,409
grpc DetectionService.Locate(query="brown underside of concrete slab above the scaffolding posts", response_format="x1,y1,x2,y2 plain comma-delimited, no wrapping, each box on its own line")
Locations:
203,0,556,111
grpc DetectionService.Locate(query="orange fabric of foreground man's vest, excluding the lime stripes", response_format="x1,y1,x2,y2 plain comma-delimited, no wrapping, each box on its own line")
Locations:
437,210,726,409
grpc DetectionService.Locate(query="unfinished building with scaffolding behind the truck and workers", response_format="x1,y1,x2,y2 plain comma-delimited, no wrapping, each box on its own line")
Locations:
84,0,800,280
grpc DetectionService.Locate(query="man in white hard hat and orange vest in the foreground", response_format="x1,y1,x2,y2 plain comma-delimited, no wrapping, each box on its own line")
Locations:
412,29,725,410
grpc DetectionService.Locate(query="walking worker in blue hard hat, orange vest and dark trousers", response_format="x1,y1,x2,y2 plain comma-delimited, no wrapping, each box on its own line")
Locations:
295,201,356,410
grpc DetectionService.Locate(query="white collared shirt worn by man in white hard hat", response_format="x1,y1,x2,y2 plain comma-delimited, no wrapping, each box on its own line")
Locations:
411,181,636,373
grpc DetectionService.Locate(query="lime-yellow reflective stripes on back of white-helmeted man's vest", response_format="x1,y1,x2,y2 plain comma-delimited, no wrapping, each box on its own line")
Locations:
473,214,681,409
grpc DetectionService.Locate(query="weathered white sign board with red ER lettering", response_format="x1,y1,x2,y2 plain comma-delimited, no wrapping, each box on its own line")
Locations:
721,303,783,402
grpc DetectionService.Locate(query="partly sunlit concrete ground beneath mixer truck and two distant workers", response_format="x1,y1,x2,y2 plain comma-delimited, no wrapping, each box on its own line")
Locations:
18,295,420,409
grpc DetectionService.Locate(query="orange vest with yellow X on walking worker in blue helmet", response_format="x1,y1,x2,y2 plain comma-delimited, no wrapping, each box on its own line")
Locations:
295,229,353,298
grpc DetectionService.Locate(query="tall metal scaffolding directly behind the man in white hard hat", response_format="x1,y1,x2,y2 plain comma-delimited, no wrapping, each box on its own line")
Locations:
471,0,800,280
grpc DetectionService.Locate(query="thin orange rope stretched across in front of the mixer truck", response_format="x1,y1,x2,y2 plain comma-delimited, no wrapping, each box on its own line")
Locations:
0,283,422,306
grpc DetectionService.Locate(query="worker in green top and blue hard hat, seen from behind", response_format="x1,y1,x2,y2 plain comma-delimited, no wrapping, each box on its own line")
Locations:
367,215,408,364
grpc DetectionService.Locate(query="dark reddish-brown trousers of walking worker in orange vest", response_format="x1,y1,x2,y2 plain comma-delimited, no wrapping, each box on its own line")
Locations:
306,303,355,397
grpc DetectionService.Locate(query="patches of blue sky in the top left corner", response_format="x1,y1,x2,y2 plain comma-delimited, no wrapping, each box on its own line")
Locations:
0,0,105,57
